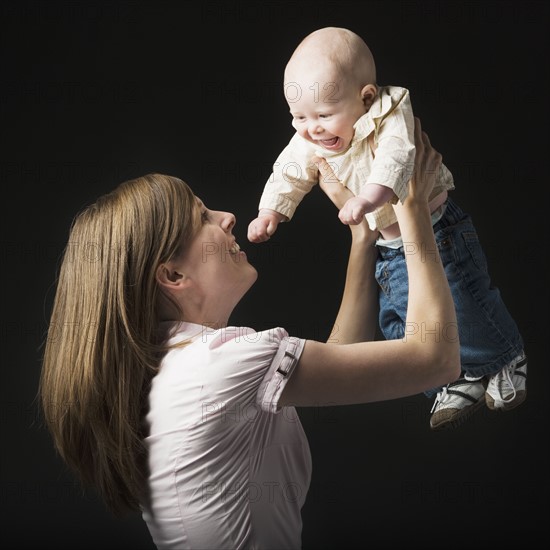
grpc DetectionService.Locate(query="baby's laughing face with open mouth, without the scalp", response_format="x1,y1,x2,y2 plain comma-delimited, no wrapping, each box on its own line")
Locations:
285,70,367,153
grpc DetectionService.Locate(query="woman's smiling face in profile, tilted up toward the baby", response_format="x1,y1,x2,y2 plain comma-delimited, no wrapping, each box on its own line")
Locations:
178,198,258,322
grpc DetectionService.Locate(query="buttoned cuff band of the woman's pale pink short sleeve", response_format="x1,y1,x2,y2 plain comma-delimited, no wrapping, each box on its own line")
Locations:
256,336,305,413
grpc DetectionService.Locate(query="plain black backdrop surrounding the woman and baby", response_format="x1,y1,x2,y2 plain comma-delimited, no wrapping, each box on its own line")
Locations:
0,1,549,550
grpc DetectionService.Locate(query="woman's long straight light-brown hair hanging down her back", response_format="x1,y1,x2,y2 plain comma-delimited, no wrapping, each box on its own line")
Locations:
39,174,199,515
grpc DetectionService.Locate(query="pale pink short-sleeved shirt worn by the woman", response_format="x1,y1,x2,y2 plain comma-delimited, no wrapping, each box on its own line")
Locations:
143,323,311,550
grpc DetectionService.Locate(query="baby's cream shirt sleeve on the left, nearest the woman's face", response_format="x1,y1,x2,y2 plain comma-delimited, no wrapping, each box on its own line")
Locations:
259,134,318,220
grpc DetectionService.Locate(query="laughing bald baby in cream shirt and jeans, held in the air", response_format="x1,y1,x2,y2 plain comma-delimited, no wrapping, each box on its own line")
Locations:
248,27,527,429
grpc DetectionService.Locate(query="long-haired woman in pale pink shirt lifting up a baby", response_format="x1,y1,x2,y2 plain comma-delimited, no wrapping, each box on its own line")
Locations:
40,120,460,548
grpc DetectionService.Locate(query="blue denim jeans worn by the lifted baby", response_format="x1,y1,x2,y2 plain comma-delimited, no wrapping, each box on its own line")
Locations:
376,199,523,397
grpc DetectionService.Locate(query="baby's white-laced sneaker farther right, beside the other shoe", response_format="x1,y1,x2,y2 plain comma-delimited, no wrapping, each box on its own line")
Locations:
485,355,527,411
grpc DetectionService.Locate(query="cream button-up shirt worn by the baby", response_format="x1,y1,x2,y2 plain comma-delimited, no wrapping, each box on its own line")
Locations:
259,86,454,230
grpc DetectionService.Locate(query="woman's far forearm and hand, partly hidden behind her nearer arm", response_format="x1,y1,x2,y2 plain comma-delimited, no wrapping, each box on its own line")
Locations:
313,157,378,344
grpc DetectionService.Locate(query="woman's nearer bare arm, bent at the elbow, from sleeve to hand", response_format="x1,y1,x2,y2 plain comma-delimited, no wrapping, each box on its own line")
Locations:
279,120,460,406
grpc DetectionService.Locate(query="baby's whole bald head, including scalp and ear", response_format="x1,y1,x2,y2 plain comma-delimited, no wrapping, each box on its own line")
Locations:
284,27,377,152
